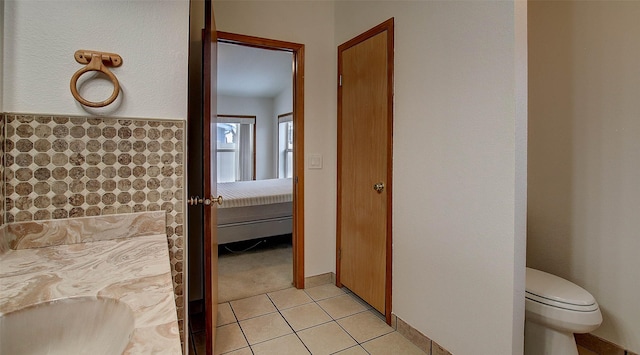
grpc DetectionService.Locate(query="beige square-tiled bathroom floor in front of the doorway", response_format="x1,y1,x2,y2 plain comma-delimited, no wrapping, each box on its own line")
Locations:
192,284,425,355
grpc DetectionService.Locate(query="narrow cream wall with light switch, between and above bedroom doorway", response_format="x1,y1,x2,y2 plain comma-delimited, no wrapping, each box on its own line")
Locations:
213,1,337,276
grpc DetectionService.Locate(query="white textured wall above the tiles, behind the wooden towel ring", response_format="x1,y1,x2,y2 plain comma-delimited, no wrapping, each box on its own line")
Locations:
3,0,189,119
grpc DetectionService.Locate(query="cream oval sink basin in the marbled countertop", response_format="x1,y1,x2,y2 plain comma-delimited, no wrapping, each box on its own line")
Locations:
0,297,134,355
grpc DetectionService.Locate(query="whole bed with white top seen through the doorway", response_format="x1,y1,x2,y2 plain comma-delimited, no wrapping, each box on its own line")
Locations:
218,179,293,244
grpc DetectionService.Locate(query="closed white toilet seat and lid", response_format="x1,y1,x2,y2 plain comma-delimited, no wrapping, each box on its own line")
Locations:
525,268,598,312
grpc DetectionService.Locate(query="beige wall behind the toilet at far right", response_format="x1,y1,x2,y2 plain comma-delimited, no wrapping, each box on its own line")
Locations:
527,1,640,353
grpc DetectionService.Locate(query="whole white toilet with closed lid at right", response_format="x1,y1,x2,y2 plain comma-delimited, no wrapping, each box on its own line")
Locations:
524,268,602,355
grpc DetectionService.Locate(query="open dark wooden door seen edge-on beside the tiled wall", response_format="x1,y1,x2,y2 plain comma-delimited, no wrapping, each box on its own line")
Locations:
185,0,218,354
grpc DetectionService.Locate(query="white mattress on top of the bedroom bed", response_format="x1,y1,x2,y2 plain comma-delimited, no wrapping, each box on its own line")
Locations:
218,178,293,209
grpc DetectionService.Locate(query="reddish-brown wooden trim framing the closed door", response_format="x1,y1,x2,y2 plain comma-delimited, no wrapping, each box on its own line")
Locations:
336,18,394,324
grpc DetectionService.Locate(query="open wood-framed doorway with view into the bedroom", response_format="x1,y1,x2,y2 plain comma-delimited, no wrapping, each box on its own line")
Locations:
217,32,304,302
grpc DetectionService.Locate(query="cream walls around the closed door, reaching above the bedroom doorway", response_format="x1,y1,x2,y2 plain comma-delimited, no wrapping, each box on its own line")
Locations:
214,1,526,354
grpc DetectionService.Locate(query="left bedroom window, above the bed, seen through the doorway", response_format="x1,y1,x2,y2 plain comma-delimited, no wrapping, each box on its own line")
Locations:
216,115,256,182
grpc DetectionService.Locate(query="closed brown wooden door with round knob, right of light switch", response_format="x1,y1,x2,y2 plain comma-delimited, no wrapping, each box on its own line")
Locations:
336,19,393,322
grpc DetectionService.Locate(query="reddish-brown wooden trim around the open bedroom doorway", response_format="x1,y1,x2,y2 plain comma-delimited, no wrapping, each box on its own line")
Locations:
211,31,304,288
